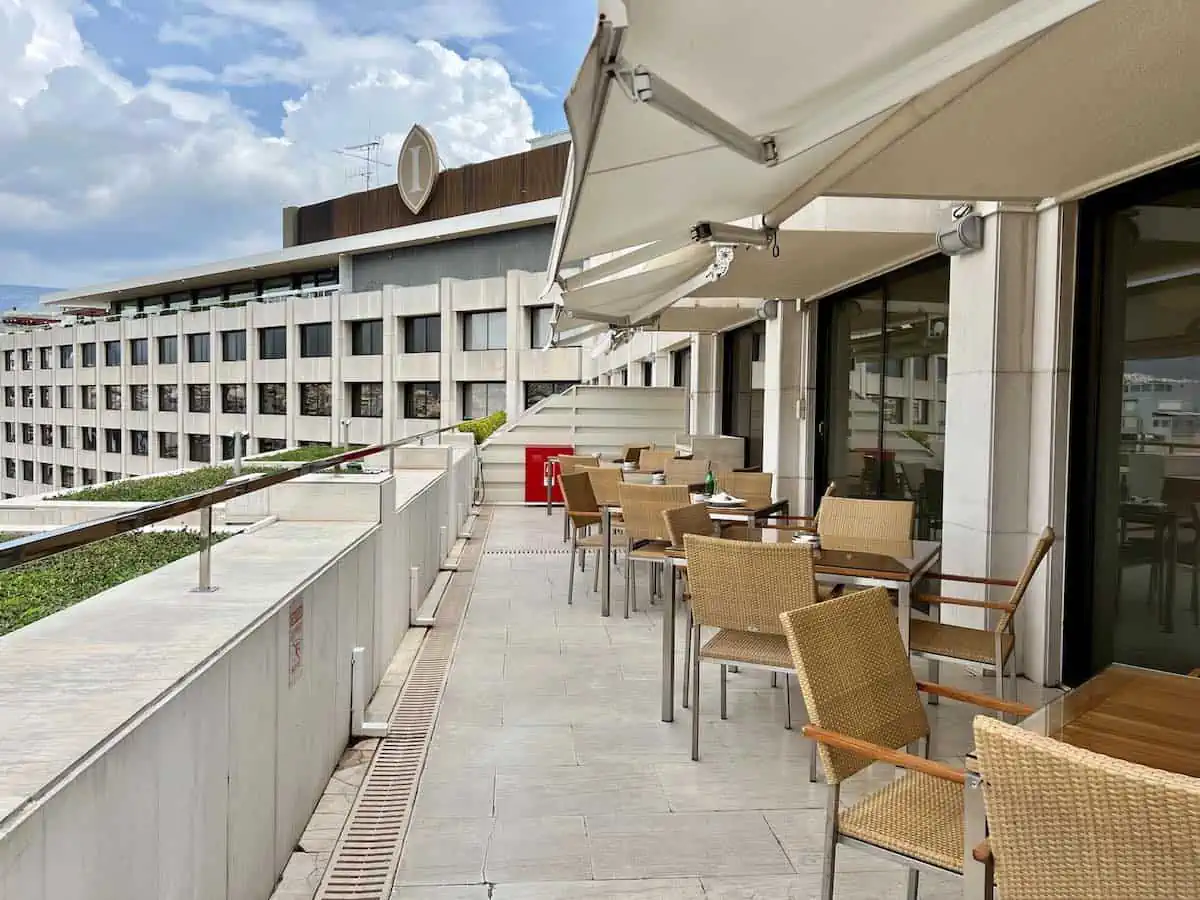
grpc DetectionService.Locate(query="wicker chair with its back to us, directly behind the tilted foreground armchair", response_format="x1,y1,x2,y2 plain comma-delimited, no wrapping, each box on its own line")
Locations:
684,534,816,760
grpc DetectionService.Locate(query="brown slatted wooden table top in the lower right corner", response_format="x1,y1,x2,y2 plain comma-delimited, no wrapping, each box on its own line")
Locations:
1021,665,1200,778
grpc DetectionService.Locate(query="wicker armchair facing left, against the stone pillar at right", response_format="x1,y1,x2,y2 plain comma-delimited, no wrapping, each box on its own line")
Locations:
908,528,1055,700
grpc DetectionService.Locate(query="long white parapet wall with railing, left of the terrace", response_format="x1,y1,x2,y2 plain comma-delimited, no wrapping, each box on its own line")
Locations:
0,449,474,900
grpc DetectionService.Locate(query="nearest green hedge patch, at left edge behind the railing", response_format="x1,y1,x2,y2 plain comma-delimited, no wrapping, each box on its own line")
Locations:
0,532,228,635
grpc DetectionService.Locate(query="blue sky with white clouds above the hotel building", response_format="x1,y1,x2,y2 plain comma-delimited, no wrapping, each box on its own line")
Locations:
0,0,595,288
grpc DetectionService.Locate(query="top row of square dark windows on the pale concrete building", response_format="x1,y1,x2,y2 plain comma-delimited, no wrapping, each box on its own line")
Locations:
4,306,553,372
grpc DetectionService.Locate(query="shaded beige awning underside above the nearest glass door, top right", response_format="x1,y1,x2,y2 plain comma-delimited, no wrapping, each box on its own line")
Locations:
827,0,1200,202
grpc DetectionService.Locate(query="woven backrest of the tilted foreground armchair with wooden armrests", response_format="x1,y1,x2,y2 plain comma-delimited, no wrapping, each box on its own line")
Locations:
772,588,929,785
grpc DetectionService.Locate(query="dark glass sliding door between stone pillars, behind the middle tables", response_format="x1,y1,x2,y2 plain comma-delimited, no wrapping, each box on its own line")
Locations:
816,257,949,536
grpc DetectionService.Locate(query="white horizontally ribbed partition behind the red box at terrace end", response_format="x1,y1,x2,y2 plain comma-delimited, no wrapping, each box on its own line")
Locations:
481,384,688,503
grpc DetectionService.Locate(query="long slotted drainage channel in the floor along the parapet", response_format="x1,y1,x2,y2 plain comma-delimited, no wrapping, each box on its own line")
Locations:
314,516,490,900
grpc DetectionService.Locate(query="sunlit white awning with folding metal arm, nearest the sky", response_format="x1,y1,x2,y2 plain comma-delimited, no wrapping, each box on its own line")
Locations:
551,0,1097,277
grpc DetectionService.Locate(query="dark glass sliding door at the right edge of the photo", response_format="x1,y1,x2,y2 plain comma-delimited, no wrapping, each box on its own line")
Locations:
1064,166,1200,683
